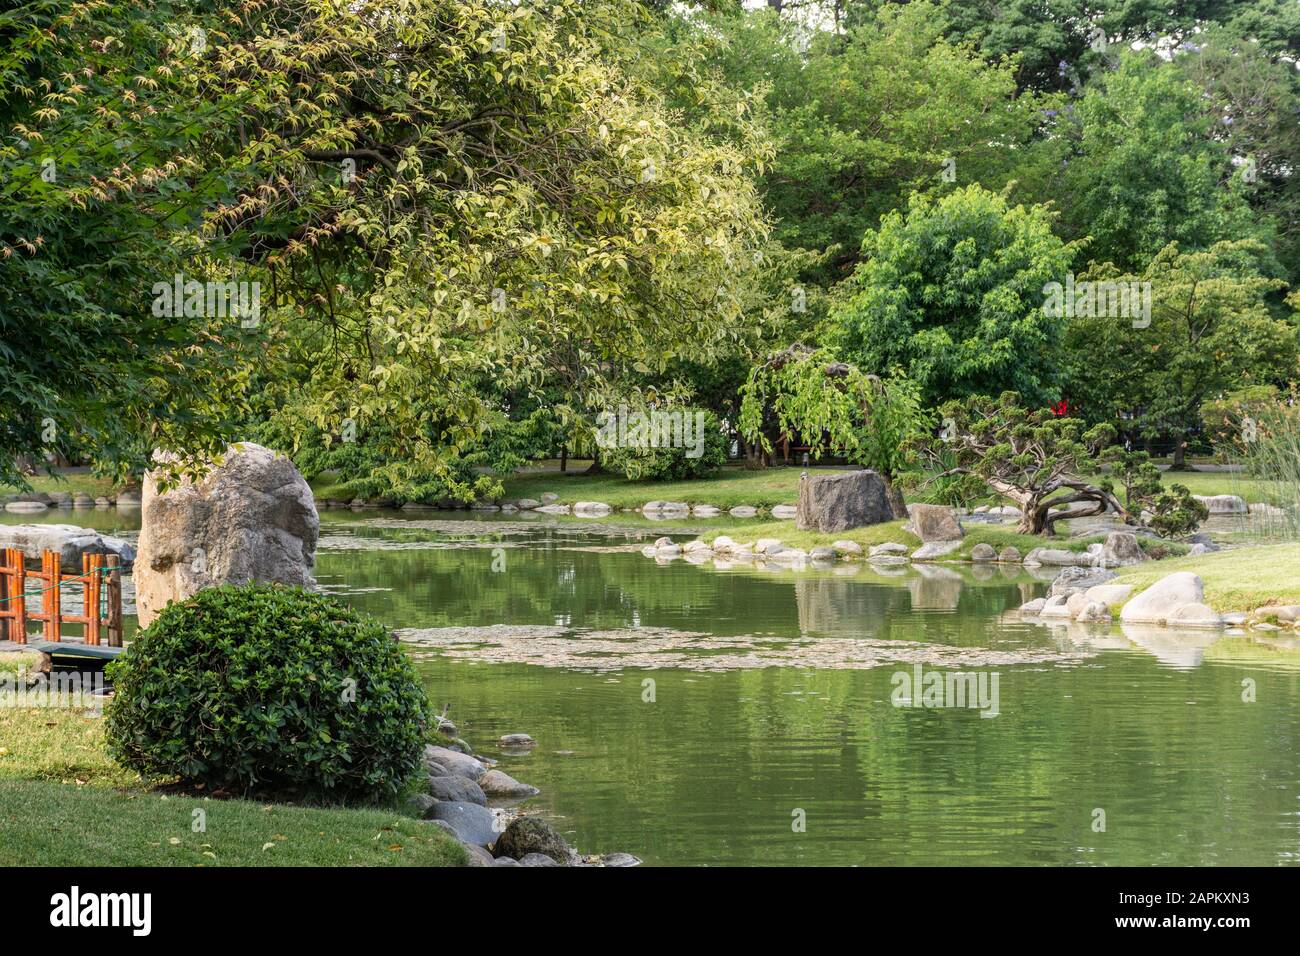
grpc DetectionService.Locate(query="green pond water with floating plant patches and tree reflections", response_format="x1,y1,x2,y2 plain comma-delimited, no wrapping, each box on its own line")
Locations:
5,511,1300,865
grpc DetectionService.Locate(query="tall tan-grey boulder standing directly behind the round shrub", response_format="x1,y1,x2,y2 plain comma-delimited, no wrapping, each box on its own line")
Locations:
135,442,320,627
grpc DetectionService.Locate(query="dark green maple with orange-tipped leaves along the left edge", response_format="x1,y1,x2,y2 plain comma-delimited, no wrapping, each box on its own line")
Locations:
0,1,252,484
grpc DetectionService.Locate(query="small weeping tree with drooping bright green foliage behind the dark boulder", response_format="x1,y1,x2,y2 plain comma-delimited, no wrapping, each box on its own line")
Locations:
740,342,931,519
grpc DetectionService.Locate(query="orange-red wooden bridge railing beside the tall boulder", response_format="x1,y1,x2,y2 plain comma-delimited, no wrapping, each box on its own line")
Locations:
0,548,122,648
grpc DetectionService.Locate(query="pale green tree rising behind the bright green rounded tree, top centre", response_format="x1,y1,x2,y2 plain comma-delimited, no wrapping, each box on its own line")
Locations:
662,3,1054,286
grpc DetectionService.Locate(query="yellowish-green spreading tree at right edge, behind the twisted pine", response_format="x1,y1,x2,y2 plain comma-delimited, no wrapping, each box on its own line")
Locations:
1066,239,1296,468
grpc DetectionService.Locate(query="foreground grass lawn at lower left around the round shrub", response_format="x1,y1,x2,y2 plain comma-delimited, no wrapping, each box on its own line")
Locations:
0,702,465,866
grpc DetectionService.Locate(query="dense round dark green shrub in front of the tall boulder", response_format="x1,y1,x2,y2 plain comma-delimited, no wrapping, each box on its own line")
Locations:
105,584,429,799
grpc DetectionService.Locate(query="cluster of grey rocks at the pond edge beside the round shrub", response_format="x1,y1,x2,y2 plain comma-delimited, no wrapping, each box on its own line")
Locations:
411,722,641,866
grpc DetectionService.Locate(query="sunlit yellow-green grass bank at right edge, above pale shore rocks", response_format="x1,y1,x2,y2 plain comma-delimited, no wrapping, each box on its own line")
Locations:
1119,544,1300,611
